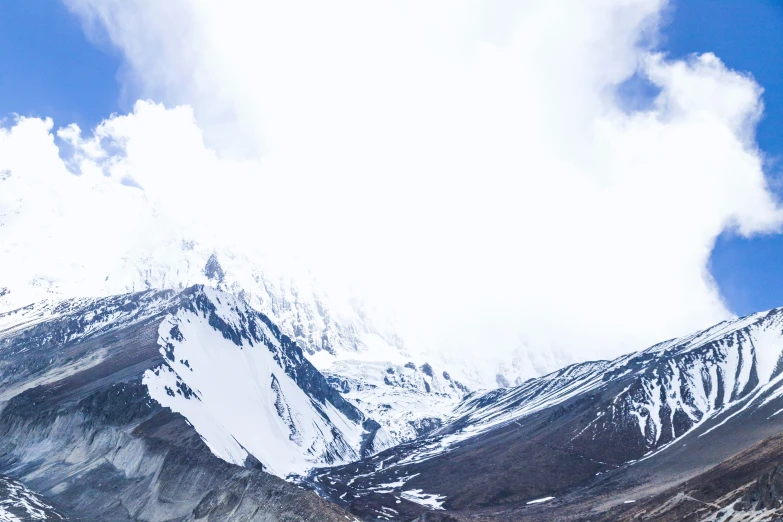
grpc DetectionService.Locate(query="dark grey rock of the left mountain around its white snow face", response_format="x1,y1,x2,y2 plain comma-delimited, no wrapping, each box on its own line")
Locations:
0,288,355,521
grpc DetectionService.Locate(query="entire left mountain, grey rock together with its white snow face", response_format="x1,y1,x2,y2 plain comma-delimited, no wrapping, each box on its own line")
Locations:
0,287,362,521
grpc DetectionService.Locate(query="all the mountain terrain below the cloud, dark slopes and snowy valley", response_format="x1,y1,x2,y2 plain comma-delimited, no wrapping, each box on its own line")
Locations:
0,276,783,521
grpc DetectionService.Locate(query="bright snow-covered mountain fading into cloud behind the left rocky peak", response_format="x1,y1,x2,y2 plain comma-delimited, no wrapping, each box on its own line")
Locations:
0,164,414,370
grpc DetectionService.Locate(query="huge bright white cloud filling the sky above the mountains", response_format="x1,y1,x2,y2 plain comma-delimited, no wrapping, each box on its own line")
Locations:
0,0,781,382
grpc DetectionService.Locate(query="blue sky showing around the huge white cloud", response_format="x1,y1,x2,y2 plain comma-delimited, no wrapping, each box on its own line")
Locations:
0,0,783,314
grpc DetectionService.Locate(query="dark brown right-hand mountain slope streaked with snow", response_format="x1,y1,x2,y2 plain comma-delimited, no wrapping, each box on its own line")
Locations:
312,309,783,520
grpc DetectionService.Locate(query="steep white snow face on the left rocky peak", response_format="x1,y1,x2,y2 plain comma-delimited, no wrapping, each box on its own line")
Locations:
143,288,370,477
